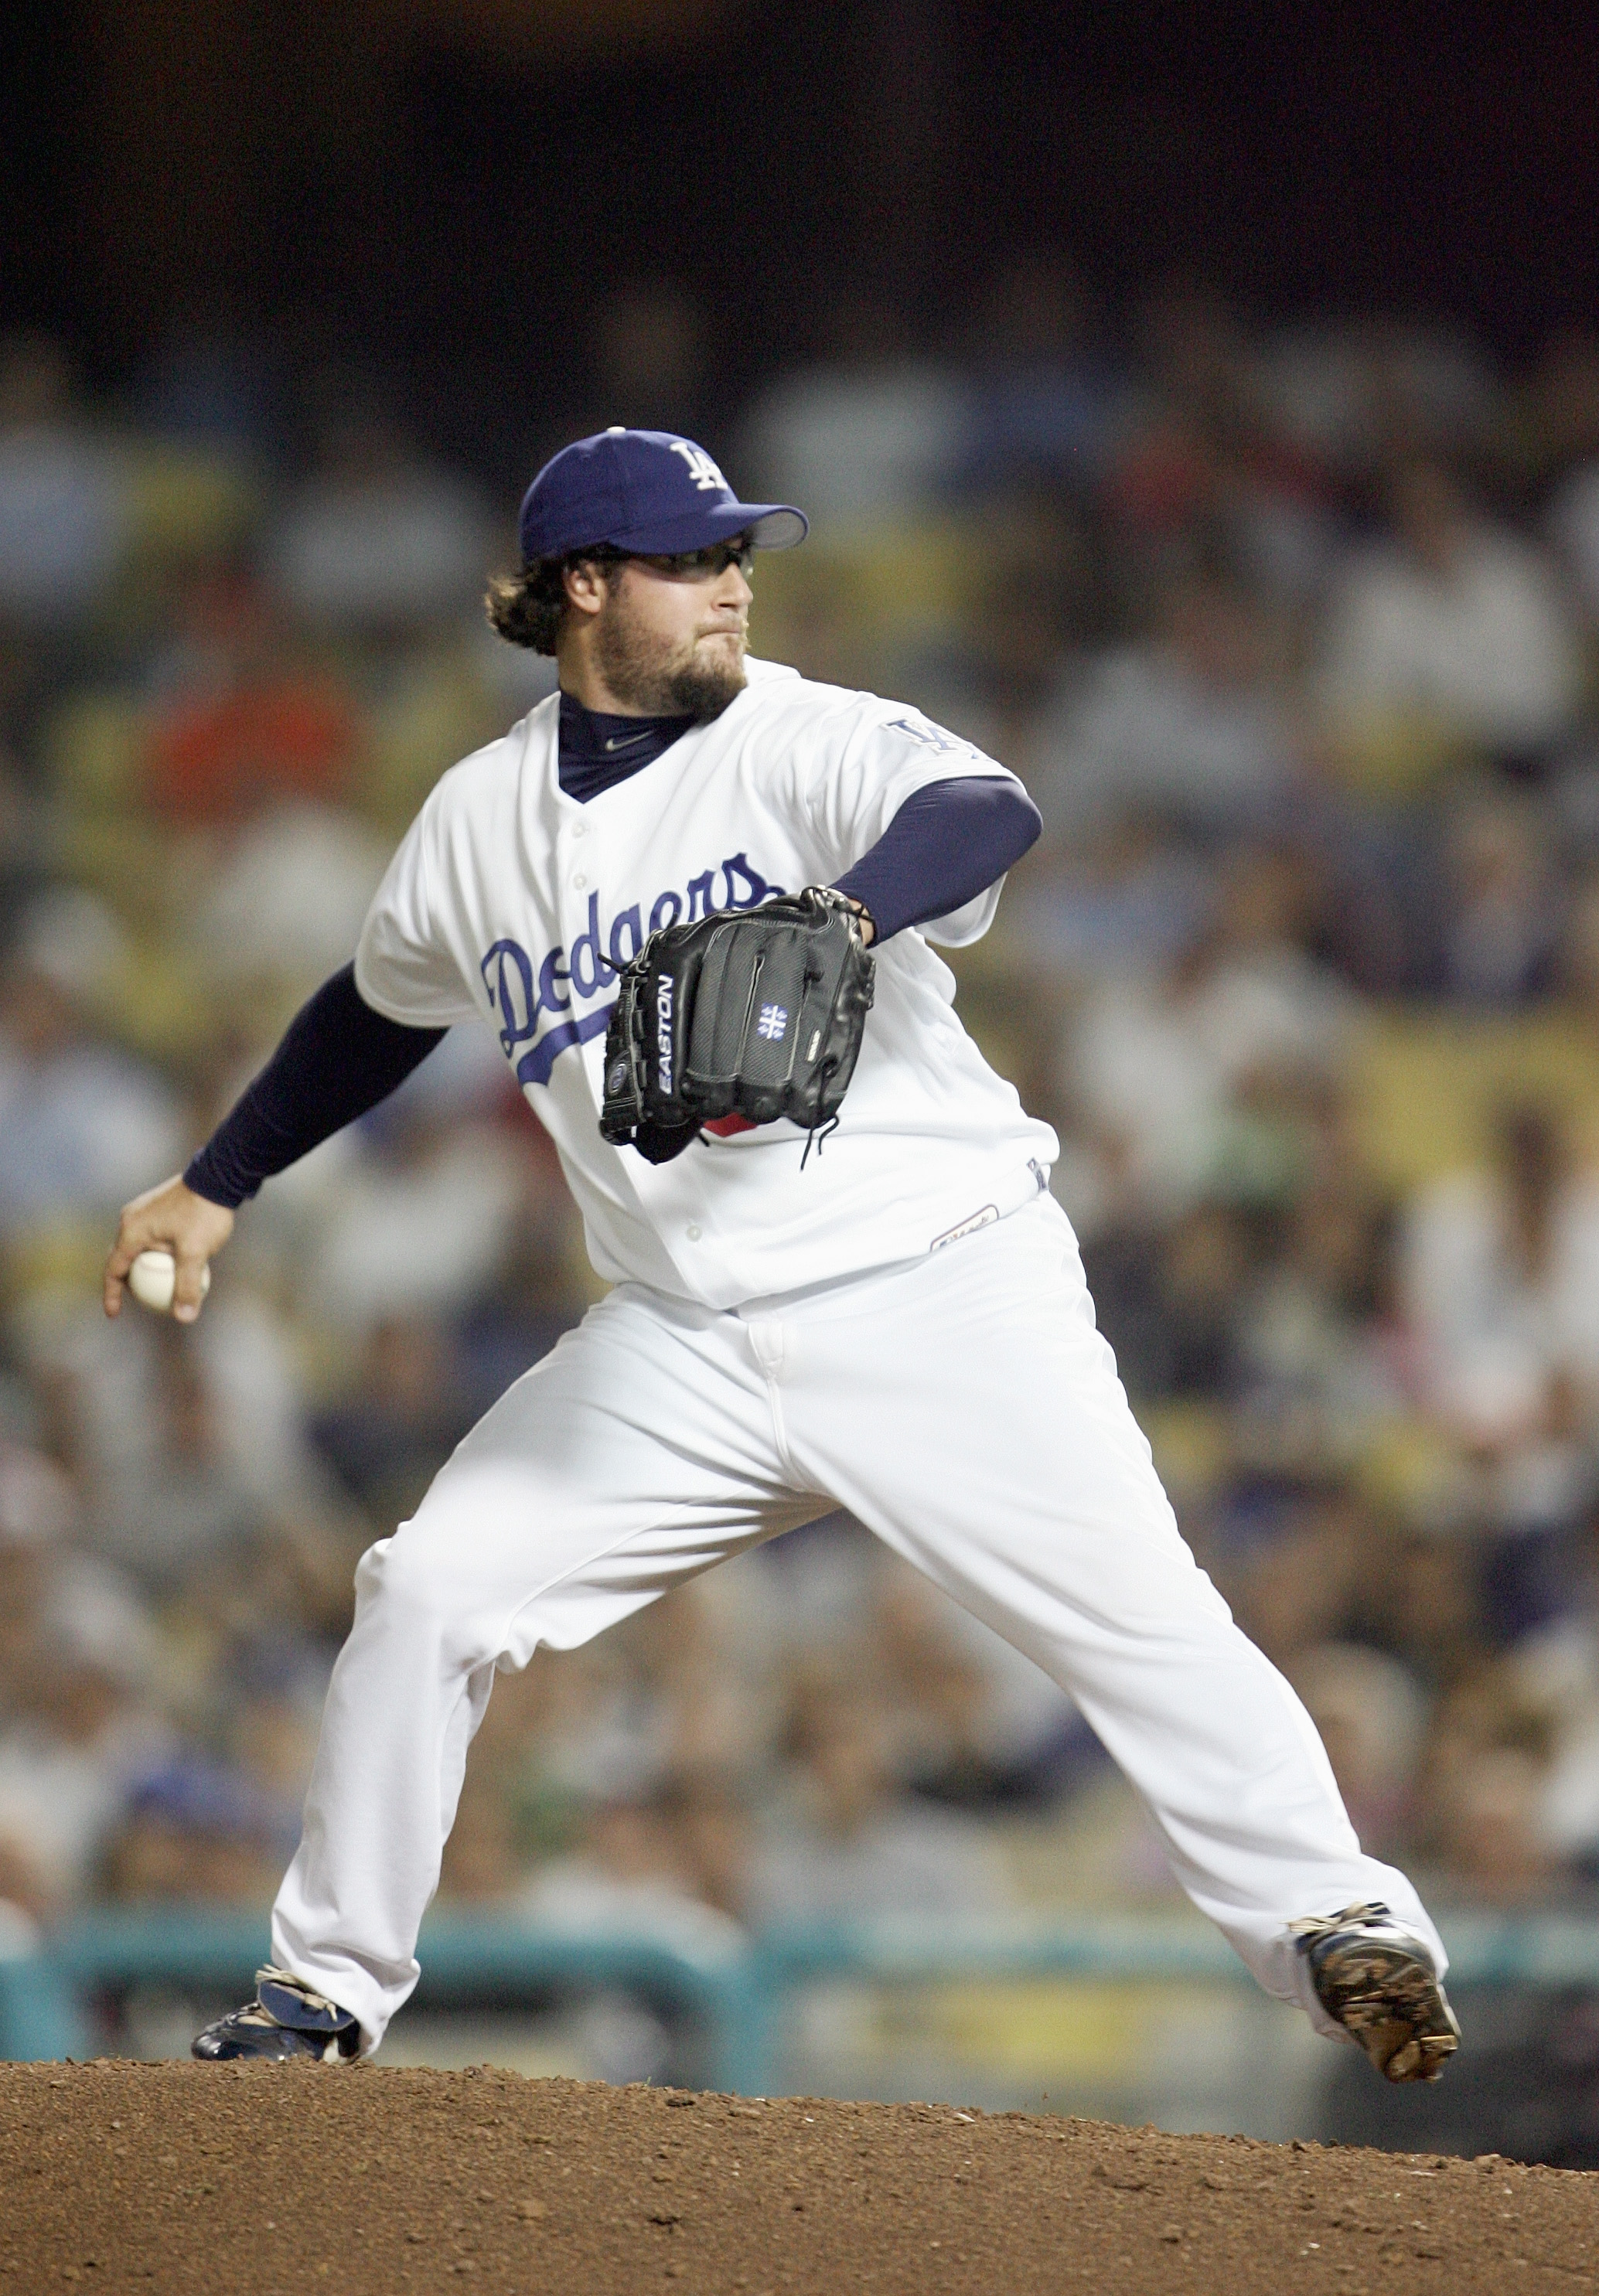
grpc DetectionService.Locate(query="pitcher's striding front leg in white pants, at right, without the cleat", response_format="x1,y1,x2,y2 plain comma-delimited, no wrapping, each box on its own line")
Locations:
765,1201,1445,2075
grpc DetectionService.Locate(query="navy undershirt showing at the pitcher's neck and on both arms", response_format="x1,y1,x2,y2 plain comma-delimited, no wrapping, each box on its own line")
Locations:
184,693,1041,1208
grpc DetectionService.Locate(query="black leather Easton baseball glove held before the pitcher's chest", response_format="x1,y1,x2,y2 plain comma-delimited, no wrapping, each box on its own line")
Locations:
600,884,873,1164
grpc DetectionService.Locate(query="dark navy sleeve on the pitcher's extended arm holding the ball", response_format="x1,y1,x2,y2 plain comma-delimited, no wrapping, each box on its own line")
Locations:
184,964,445,1210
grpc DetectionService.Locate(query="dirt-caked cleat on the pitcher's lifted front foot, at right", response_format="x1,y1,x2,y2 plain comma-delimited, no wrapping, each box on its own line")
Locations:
1289,1906,1461,2080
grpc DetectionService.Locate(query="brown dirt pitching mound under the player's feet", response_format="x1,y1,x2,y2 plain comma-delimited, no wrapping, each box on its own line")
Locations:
0,2062,1599,2296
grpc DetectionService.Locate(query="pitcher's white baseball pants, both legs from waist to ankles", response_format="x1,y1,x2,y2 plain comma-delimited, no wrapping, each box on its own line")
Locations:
274,1198,1443,2048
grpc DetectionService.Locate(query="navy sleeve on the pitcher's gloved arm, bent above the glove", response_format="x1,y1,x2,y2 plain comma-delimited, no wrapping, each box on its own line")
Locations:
839,776,1043,949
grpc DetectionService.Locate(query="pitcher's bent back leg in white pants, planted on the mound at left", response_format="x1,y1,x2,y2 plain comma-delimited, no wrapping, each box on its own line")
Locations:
198,1286,830,2055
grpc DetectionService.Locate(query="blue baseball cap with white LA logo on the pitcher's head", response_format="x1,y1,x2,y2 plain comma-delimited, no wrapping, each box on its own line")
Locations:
521,422,809,565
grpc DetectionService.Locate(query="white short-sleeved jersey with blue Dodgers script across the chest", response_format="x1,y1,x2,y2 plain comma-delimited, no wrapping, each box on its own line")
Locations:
356,661,1059,1309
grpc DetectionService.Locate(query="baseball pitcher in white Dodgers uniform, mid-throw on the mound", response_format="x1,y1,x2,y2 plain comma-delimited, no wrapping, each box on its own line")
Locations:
106,429,1457,2080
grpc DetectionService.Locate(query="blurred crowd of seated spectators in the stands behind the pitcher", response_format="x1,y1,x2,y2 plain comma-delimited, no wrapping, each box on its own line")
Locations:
0,257,1599,2039
